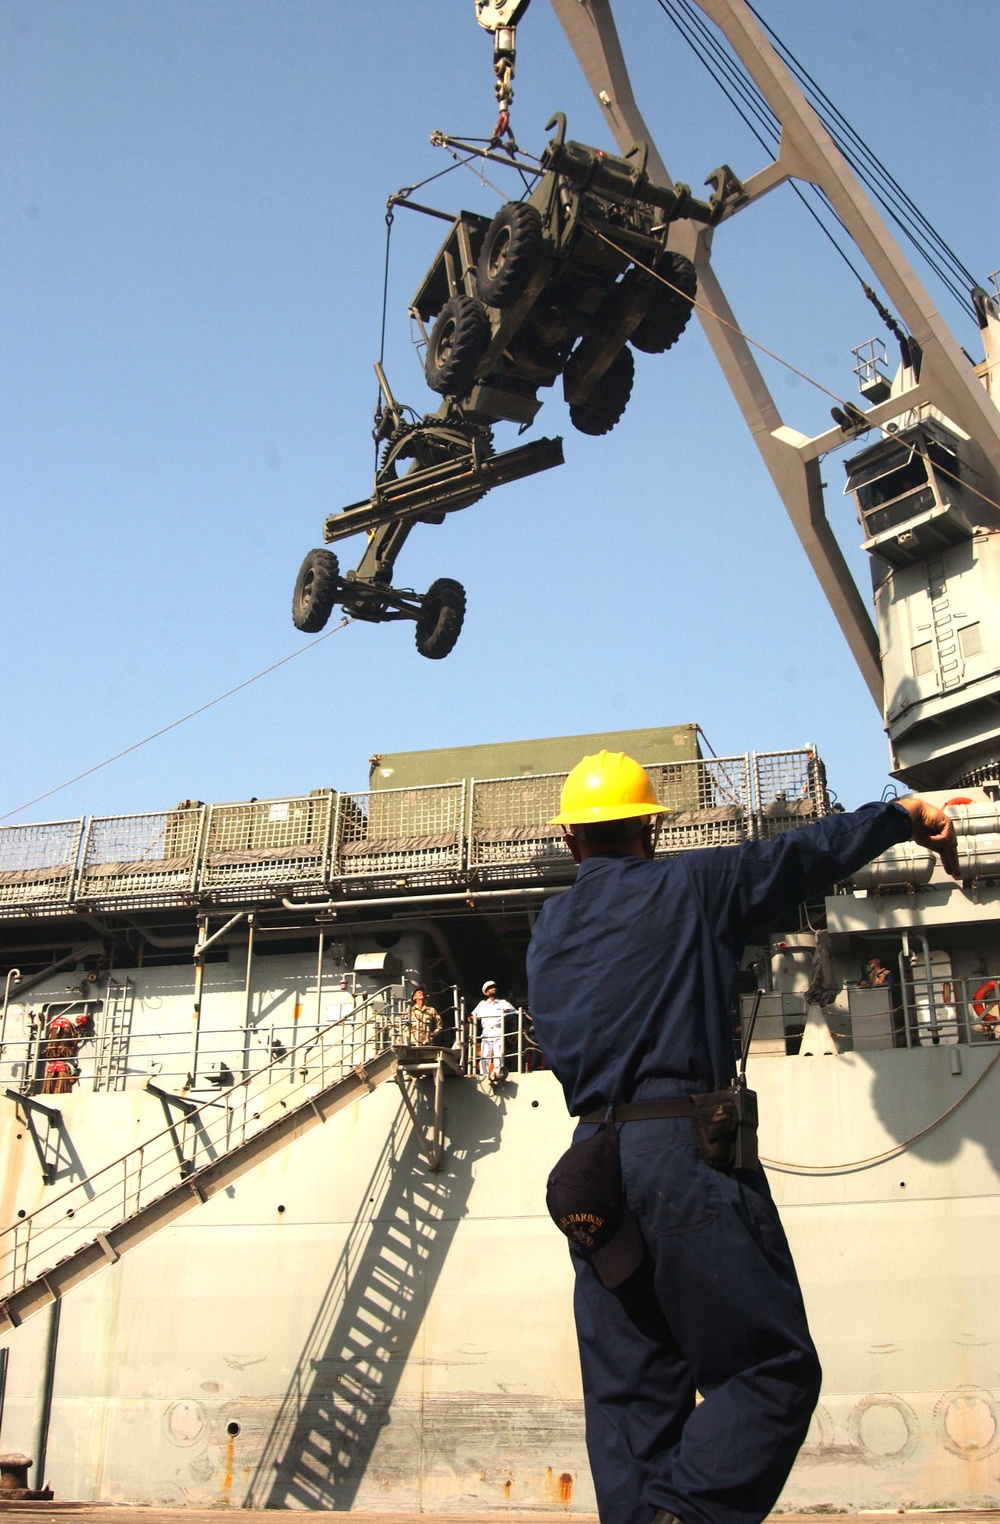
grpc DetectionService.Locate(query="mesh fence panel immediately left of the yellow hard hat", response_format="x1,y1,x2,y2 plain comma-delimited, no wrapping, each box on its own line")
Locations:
468,773,575,881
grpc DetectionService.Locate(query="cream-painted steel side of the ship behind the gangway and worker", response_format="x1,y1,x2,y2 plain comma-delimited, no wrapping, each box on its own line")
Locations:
0,932,1000,1512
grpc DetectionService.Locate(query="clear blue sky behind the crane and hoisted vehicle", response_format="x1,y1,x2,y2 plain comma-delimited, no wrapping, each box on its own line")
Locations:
0,0,1000,821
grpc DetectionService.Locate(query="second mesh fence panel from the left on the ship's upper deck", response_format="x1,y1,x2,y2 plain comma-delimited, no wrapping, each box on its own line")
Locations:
76,805,204,907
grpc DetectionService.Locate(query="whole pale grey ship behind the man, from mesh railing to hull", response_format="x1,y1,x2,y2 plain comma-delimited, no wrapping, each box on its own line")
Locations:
0,725,1000,1509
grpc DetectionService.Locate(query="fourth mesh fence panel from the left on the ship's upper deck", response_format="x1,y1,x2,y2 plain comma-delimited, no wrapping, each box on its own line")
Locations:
334,783,465,888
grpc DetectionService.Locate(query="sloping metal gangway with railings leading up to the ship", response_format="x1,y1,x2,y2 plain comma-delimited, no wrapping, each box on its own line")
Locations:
0,989,462,1334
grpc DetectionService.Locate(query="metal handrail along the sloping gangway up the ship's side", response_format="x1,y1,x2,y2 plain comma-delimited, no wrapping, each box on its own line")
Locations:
0,989,405,1298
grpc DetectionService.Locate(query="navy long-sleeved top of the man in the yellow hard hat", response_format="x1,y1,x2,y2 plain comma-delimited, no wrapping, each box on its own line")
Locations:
527,803,912,1116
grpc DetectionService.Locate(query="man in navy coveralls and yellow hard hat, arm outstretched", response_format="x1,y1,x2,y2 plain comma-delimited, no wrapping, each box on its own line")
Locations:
527,751,959,1524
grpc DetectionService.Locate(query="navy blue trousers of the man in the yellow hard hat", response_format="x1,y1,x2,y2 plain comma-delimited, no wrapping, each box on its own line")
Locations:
572,1082,820,1524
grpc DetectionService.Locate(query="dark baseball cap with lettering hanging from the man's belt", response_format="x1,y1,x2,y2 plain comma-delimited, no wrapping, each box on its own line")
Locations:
546,1122,645,1288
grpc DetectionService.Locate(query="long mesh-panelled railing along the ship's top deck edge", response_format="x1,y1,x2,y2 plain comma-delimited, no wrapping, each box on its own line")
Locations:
0,747,829,917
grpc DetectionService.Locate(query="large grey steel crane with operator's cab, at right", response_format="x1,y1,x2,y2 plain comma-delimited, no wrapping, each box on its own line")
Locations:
552,0,1000,789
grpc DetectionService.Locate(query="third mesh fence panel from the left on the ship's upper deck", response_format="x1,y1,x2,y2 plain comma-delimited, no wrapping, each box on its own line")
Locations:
201,789,334,899
